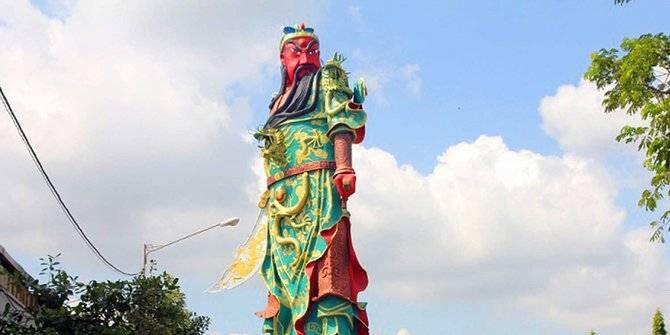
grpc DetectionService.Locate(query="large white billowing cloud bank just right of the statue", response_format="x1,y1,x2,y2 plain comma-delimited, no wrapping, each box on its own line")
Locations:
350,136,670,334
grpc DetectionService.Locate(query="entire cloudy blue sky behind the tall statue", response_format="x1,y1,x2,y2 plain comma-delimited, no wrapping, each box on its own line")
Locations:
0,0,670,335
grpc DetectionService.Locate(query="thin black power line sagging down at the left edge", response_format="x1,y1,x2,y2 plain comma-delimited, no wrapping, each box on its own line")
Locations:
0,87,139,276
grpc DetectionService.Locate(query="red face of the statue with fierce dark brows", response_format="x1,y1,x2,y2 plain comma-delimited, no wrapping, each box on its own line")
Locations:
279,37,321,87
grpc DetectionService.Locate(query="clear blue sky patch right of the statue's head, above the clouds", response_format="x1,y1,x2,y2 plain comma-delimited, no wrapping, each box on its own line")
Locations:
321,1,669,171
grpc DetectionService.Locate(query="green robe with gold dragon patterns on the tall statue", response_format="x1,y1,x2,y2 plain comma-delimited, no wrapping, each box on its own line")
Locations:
257,61,367,335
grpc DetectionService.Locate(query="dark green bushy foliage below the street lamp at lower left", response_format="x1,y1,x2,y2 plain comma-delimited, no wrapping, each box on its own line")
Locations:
0,256,210,335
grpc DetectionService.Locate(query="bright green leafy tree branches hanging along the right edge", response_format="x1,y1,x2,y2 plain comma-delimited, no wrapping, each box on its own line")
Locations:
584,34,670,242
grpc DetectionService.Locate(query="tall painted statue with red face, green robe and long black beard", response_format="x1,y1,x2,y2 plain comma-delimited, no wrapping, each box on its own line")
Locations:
213,24,368,335
